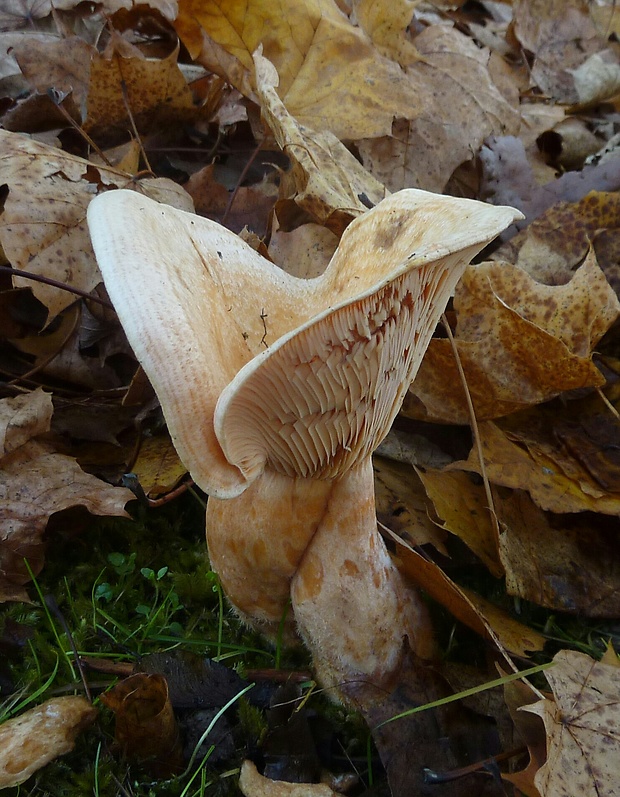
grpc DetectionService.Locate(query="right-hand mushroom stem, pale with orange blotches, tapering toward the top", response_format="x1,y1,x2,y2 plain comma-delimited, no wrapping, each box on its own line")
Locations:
291,457,434,688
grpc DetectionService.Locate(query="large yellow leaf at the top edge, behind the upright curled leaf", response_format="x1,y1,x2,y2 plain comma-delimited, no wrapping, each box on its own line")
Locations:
174,0,422,140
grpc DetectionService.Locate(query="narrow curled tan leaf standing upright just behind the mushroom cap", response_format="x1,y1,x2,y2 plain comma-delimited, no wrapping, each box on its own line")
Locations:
254,53,386,235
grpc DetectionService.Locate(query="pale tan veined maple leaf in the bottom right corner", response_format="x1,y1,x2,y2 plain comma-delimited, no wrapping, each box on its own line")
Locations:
522,650,620,797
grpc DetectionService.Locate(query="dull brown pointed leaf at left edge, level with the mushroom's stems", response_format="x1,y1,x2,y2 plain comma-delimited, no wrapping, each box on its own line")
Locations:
0,391,133,601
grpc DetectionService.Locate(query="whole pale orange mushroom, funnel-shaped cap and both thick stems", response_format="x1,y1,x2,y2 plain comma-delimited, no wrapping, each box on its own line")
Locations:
88,189,519,685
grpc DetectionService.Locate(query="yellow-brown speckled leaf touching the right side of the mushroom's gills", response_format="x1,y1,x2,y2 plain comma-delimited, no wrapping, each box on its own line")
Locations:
403,253,620,424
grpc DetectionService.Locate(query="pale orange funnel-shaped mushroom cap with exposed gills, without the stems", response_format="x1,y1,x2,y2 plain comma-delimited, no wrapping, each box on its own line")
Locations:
88,190,520,498
